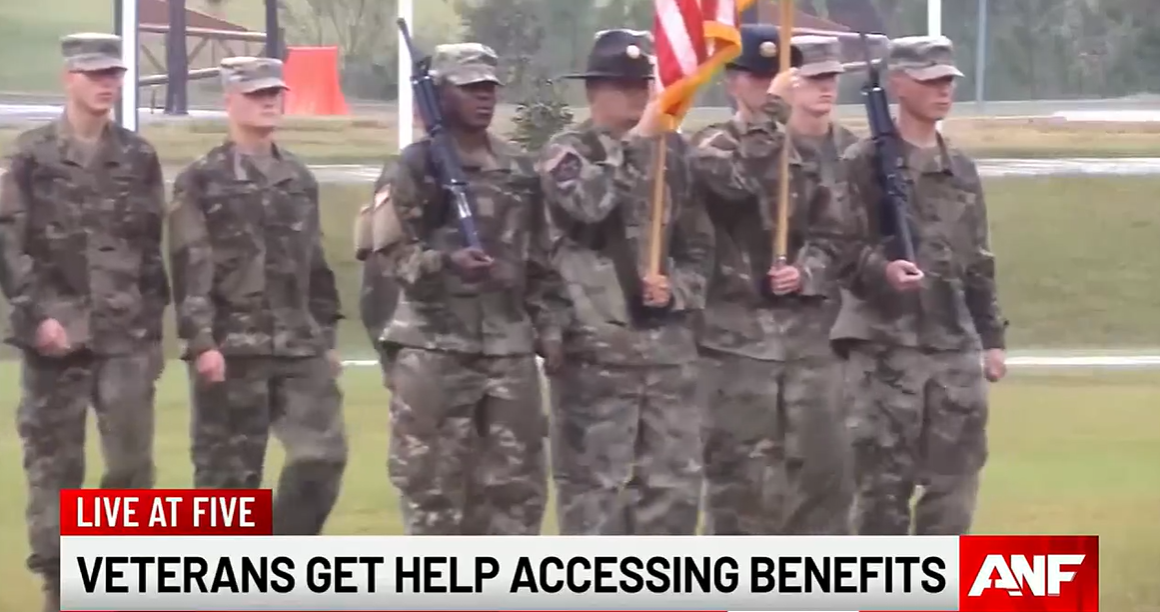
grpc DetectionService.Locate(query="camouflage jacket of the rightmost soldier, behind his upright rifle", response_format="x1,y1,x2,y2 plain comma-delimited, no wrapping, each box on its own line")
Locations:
833,137,1007,350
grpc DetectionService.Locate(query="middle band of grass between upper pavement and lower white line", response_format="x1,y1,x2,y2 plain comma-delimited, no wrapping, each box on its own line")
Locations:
0,177,1160,358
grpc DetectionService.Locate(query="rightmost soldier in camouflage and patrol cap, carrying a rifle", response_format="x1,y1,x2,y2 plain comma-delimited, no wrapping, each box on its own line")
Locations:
833,37,1006,534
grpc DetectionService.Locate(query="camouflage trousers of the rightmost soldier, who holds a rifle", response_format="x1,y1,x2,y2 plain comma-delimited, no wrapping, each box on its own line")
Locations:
847,343,987,536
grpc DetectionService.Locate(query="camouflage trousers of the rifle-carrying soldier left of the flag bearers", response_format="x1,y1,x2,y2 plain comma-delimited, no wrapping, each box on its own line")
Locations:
387,348,548,536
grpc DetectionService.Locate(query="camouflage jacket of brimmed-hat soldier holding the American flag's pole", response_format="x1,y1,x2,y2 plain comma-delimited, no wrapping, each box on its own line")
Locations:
541,122,713,365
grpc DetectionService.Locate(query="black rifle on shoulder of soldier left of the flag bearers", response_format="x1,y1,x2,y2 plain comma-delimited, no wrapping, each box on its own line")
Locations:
397,17,484,250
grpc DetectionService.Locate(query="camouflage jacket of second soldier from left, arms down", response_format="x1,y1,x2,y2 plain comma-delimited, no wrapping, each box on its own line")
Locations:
169,143,342,358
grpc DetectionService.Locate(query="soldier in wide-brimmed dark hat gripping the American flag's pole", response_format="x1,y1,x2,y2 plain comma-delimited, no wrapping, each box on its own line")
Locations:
541,30,713,534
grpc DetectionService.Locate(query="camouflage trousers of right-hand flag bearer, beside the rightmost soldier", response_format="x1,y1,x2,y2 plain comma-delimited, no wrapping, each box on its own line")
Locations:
697,350,854,536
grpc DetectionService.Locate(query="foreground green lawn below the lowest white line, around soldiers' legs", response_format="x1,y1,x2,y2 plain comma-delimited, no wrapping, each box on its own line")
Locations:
0,363,1160,612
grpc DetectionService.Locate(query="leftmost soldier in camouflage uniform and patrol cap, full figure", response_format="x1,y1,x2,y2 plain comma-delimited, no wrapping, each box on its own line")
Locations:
0,35,169,610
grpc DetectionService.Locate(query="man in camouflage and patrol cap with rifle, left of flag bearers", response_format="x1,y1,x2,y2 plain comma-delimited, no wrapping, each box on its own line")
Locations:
376,43,561,536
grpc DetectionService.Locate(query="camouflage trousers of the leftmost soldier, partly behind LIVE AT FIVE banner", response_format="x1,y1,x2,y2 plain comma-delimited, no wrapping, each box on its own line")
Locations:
16,345,165,581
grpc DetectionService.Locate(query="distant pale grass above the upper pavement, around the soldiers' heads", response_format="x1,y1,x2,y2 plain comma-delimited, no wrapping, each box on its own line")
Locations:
0,0,1160,165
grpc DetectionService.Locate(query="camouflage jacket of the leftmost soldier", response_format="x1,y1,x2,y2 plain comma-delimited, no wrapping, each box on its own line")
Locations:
0,119,169,355
